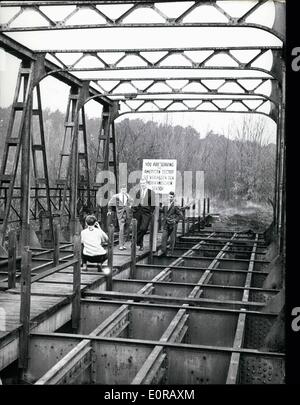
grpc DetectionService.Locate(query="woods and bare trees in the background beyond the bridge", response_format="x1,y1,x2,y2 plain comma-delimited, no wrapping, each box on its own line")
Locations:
0,108,276,202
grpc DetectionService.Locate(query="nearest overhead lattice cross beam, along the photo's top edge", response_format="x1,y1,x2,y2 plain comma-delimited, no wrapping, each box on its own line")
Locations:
1,0,285,41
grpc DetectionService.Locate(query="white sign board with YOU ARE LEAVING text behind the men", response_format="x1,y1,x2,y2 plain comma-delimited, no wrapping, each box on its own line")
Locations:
142,159,177,194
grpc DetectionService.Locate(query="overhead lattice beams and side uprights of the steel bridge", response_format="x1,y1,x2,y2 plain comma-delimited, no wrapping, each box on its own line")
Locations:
0,0,285,264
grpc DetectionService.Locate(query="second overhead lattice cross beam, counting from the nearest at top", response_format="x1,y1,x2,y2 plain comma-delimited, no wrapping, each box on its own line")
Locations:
37,46,282,80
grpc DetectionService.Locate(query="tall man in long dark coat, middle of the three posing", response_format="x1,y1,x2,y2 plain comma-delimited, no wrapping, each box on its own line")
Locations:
132,178,156,250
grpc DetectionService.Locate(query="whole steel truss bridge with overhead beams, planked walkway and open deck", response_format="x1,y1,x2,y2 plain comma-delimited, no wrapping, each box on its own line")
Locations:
0,0,286,385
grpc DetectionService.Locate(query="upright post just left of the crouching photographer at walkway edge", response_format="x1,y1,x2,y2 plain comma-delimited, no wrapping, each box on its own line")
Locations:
72,235,81,331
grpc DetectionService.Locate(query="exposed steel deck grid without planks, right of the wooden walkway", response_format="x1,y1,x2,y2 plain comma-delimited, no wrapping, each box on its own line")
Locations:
7,229,285,385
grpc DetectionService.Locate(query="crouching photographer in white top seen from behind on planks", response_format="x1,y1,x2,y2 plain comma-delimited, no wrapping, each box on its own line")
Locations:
81,215,108,271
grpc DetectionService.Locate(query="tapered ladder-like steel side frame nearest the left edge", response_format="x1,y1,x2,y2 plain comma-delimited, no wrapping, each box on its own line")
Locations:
0,61,53,245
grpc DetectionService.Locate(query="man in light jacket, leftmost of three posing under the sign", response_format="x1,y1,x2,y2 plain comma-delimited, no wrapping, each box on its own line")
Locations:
107,184,133,250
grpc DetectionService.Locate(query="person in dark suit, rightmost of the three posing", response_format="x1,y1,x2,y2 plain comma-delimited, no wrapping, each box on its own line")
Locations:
161,191,183,255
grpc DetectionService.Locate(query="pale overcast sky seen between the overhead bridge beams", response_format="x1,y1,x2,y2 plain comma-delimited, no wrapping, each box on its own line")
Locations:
0,0,281,142
